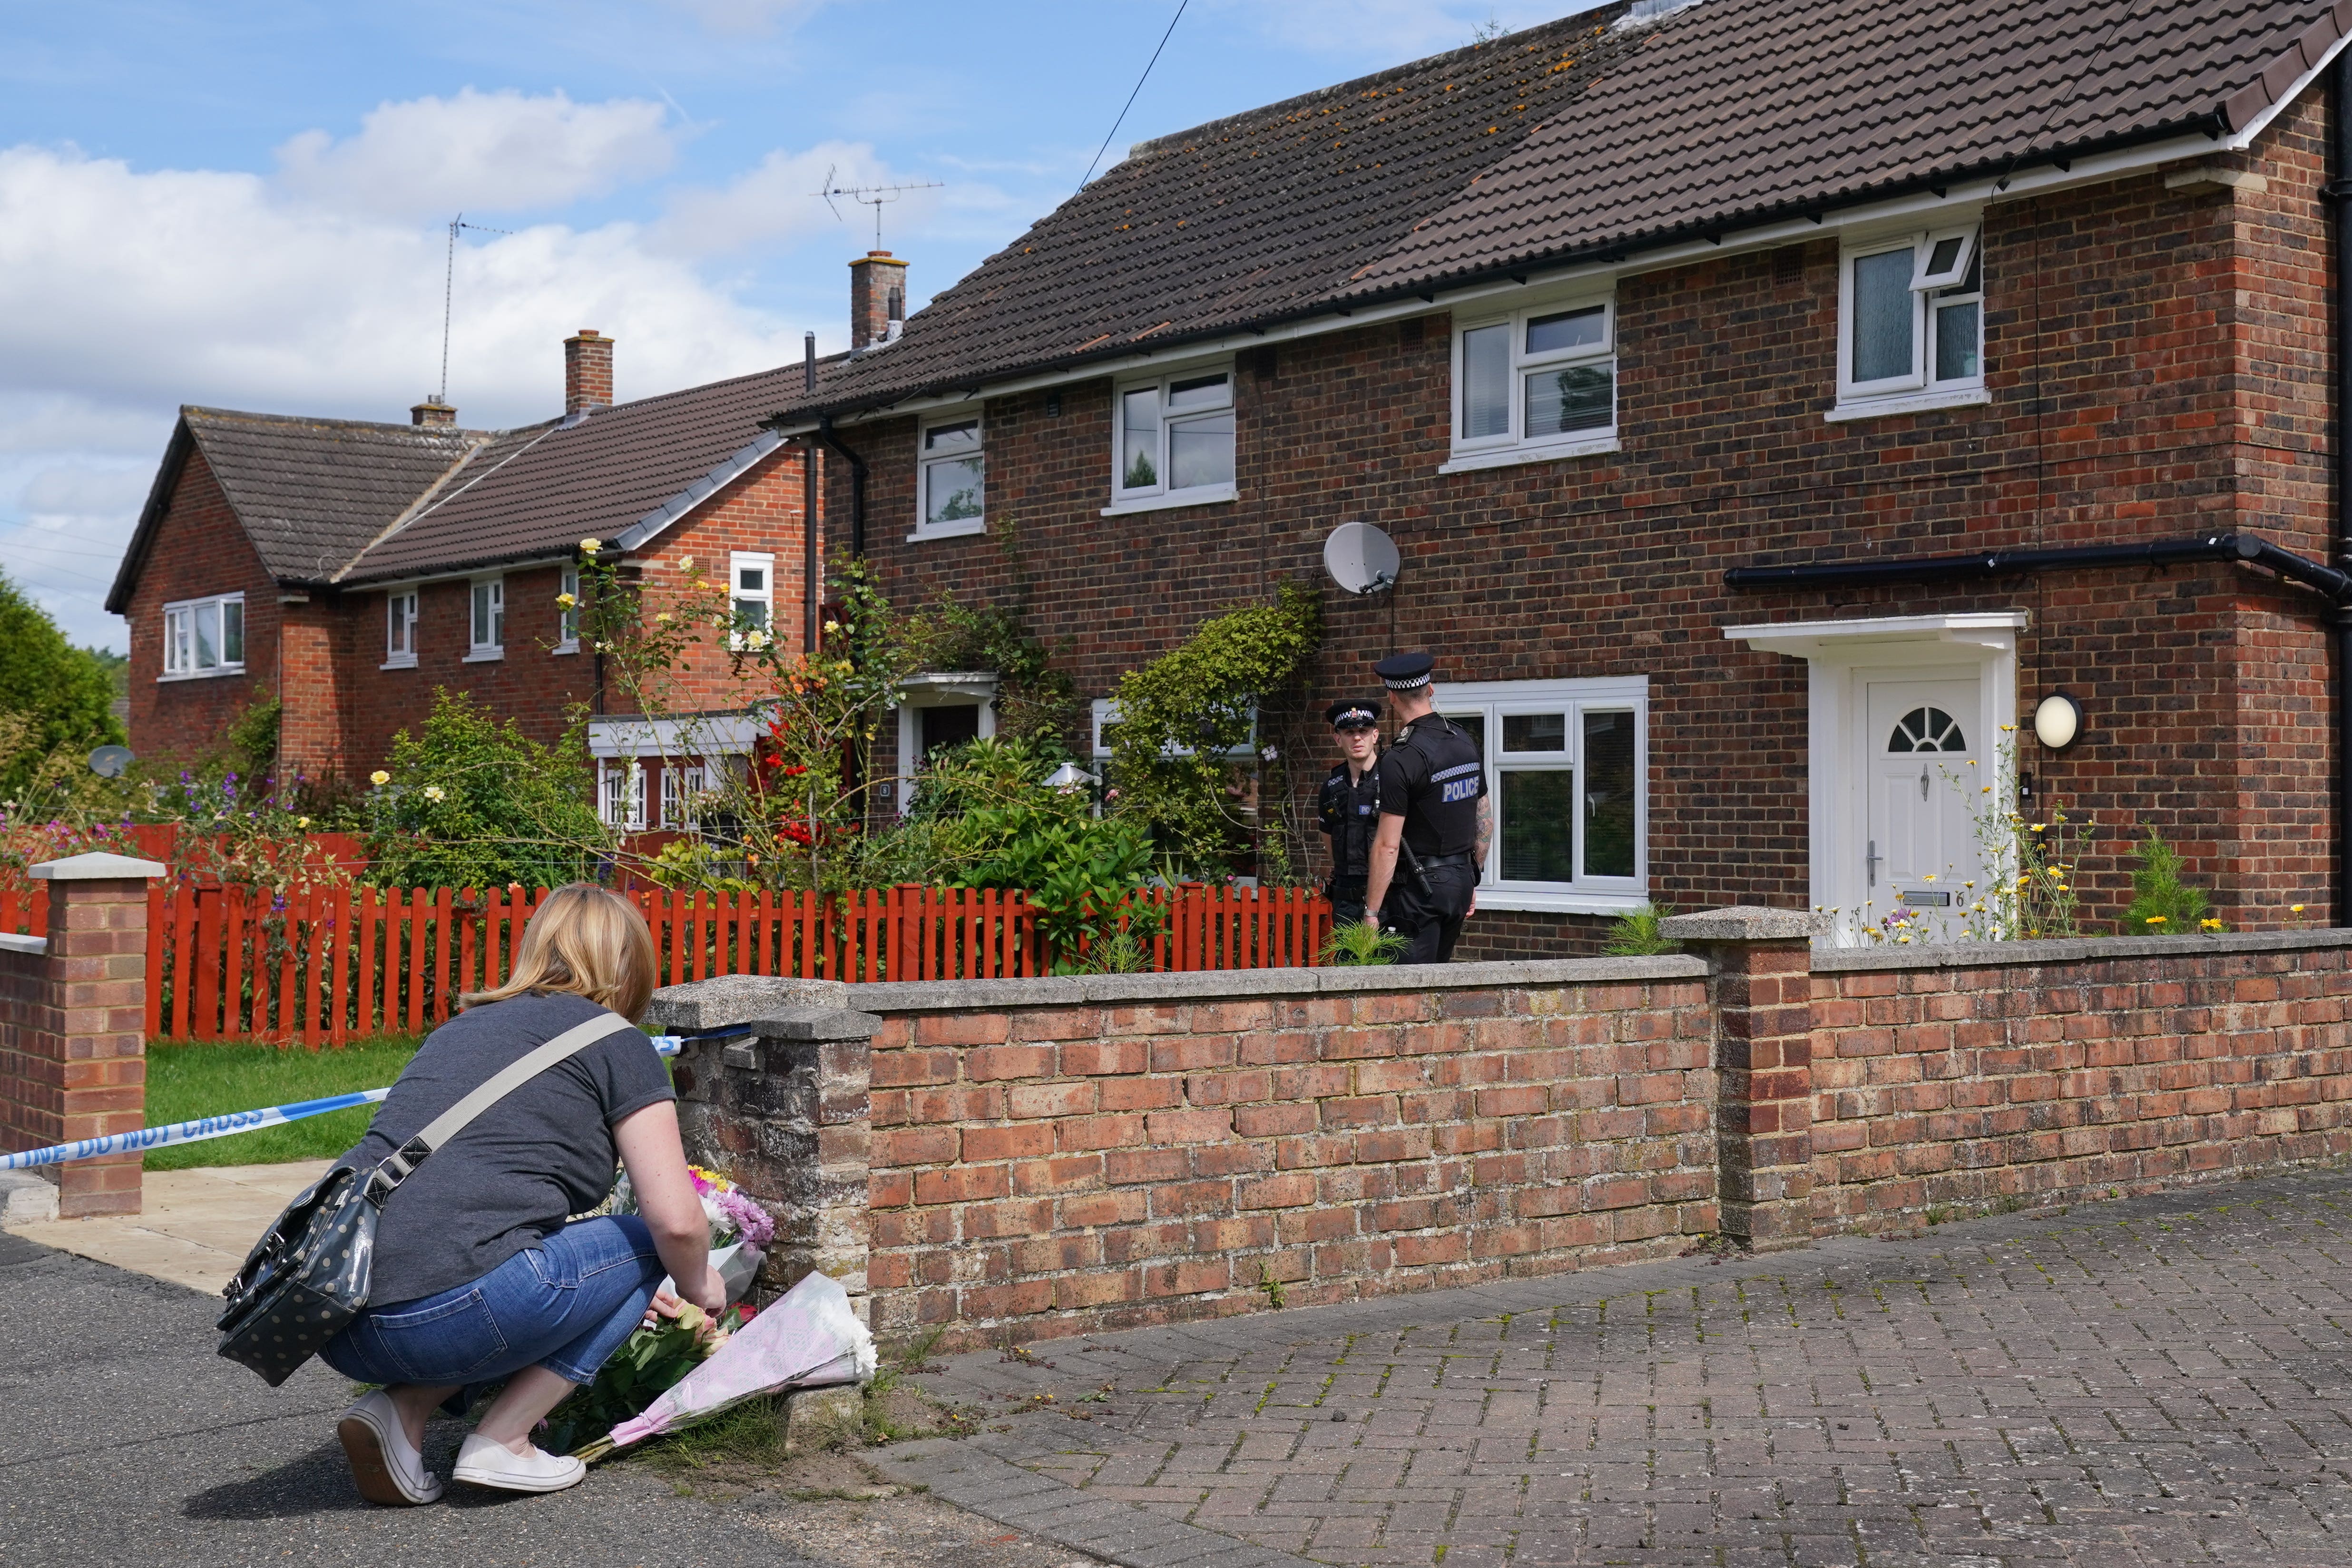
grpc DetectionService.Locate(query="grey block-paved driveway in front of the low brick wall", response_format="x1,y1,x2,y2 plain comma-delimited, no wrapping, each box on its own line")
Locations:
884,1173,2352,1568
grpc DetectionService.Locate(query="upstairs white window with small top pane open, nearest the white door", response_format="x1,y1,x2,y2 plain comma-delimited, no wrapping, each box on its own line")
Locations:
1830,223,1985,419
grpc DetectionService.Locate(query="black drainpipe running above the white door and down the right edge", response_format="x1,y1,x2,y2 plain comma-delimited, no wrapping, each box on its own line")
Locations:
1724,531,2352,926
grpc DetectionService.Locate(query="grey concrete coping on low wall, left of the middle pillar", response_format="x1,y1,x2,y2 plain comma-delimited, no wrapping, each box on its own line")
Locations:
818,957,1707,1013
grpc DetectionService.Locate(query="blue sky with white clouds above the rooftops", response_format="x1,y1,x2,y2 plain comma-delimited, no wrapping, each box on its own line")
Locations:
0,0,1580,649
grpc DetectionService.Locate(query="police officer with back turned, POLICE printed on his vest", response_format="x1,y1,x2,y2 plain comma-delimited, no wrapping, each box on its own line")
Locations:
1364,654,1493,964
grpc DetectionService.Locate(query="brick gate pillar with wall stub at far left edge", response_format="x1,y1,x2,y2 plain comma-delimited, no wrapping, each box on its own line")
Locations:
0,853,165,1218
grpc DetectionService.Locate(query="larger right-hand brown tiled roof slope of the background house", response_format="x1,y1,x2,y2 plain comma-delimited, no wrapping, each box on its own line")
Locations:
339,364,804,583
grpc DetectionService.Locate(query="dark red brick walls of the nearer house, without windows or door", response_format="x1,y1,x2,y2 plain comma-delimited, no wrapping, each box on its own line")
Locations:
828,110,2333,954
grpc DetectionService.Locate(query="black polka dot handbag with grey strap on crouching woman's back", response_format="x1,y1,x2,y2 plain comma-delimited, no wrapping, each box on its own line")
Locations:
214,1013,630,1387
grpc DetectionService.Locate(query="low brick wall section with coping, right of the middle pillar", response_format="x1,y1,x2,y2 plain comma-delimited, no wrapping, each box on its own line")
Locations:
1811,931,2352,1234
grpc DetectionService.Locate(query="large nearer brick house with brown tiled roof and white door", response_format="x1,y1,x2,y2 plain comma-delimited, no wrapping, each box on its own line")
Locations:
772,0,2352,954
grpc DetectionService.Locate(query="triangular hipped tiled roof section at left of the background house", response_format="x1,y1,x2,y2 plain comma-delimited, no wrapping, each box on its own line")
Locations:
181,407,489,583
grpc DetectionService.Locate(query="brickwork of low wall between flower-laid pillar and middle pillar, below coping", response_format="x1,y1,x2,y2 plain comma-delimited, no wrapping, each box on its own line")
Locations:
852,976,1717,1338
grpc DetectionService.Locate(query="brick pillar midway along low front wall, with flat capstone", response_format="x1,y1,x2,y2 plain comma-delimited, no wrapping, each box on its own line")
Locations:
1658,907,1813,1251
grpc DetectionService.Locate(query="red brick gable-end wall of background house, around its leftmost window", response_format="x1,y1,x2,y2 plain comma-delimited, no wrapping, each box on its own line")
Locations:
125,451,280,762
